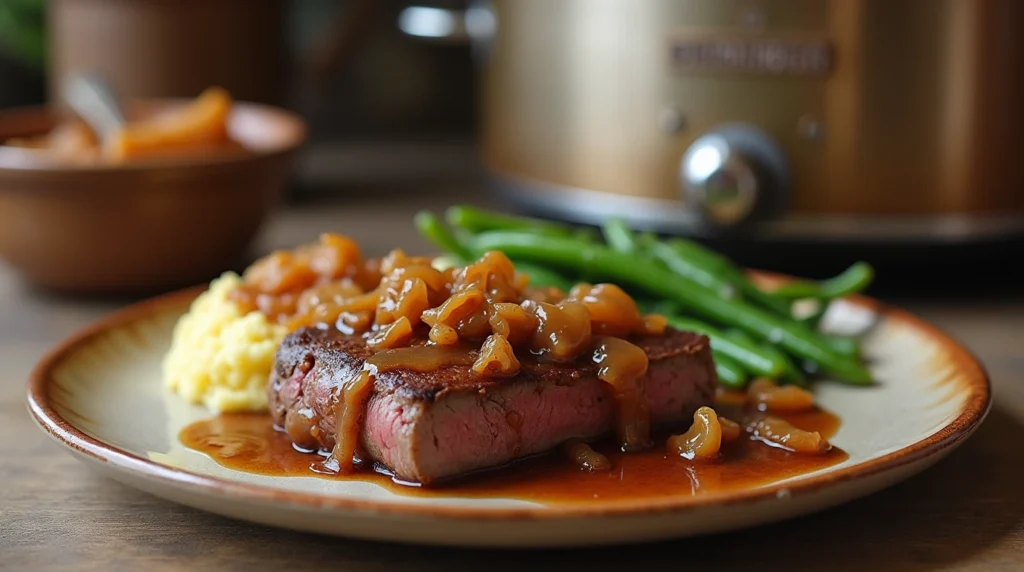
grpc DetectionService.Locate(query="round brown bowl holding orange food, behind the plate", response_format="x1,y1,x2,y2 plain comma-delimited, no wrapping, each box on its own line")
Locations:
0,99,306,295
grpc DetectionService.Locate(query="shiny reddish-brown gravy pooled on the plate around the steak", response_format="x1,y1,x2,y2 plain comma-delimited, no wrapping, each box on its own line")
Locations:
179,406,848,502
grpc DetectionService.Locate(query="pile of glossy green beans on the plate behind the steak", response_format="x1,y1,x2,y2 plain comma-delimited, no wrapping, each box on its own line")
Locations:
415,205,873,389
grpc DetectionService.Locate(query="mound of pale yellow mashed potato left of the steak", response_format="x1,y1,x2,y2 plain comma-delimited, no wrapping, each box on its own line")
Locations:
164,272,287,411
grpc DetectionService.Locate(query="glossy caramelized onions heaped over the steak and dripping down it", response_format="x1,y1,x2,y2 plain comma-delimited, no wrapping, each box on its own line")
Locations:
231,241,667,478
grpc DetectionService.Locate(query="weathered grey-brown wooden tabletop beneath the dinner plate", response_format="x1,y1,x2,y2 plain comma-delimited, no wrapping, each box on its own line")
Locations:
0,190,1024,572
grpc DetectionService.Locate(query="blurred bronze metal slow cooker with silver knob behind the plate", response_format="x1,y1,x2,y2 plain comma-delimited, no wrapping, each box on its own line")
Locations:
399,0,1024,241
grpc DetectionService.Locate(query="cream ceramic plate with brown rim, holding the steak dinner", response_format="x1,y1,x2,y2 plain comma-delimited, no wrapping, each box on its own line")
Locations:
29,284,990,546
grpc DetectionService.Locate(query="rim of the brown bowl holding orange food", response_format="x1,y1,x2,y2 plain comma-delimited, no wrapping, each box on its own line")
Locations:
0,97,309,175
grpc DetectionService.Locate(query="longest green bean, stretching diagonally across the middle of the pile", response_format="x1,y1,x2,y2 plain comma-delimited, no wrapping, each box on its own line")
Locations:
472,230,872,385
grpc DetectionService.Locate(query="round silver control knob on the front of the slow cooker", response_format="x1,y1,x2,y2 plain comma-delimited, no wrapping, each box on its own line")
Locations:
680,126,785,228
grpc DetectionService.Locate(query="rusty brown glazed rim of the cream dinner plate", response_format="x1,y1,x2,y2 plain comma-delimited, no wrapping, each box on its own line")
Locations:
27,285,992,521
